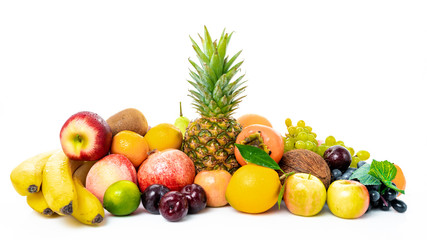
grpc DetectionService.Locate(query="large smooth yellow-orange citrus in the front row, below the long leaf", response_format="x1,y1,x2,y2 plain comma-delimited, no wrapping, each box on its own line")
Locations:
225,164,281,213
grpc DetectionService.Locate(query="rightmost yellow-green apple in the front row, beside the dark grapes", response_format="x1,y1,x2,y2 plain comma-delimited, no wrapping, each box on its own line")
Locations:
327,180,369,219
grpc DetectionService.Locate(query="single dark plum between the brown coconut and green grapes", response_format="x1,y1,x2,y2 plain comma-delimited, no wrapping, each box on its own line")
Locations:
323,145,351,172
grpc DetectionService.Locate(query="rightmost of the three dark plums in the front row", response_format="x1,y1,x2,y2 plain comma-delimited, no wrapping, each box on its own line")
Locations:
181,183,207,214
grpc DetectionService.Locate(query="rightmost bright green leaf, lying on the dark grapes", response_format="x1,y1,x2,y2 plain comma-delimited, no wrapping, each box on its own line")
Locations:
368,159,405,194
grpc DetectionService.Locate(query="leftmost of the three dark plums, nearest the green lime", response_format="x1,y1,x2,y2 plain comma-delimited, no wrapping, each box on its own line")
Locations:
141,184,170,214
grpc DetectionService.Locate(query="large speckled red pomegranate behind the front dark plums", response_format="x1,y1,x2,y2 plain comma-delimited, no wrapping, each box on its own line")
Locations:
138,149,195,192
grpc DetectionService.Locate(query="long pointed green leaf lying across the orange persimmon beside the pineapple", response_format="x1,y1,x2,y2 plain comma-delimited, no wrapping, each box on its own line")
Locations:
234,143,283,172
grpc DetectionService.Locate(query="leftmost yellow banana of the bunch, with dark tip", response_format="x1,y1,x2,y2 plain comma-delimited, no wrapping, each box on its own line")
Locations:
10,151,55,196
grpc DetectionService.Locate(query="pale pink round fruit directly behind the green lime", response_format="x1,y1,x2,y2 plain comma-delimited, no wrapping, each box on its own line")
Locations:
86,154,136,202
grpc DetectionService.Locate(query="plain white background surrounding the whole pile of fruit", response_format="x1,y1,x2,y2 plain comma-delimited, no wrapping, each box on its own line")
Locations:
0,0,427,239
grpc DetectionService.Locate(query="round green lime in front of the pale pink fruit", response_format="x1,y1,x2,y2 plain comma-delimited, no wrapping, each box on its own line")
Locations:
104,180,141,216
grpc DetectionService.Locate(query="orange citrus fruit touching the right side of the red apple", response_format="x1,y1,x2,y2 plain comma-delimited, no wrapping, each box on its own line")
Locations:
111,130,150,168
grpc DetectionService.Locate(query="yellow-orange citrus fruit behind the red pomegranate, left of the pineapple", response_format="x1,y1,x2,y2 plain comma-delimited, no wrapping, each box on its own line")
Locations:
144,123,182,151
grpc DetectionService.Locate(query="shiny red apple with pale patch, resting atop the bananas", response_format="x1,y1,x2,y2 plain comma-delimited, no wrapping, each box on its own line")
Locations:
60,111,113,161
